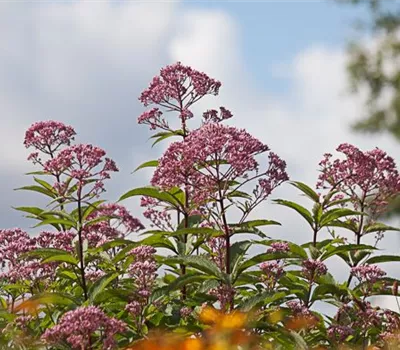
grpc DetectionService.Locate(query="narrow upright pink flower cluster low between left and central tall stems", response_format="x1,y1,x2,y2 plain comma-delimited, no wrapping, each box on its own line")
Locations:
128,245,157,302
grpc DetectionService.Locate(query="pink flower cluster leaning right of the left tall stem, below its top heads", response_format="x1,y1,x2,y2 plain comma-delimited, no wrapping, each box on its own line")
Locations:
83,203,144,247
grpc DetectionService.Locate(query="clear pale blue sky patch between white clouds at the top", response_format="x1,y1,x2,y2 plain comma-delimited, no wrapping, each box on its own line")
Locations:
184,0,370,94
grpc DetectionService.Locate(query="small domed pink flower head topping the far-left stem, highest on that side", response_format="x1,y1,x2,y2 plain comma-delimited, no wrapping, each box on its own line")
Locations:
24,120,76,158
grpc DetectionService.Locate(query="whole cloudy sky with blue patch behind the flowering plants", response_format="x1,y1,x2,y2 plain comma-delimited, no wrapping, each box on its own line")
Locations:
0,0,400,310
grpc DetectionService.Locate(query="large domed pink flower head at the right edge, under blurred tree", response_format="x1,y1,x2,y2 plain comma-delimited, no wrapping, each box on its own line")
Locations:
317,143,400,214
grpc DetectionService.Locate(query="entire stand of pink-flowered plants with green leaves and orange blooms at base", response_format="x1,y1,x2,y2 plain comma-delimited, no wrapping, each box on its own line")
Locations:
0,63,400,350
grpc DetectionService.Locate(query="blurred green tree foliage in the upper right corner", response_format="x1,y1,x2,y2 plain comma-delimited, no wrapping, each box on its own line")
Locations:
340,0,400,141
